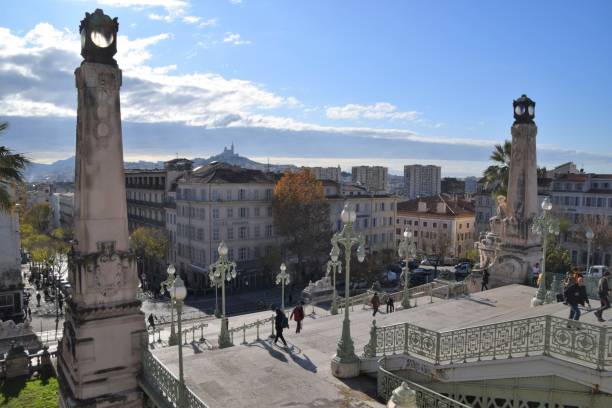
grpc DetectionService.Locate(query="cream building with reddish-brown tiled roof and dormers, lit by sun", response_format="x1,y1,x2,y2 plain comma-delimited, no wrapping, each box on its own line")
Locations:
395,195,475,258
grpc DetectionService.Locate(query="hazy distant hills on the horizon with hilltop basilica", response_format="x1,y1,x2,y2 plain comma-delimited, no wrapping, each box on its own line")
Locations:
24,146,296,182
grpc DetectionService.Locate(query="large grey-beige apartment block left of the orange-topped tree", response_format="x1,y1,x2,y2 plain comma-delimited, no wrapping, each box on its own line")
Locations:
168,163,280,291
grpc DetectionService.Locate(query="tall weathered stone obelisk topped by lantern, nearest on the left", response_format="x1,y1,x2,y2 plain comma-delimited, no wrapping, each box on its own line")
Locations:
58,9,145,408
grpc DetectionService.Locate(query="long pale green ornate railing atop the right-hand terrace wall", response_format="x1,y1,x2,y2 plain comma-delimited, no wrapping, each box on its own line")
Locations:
364,316,612,370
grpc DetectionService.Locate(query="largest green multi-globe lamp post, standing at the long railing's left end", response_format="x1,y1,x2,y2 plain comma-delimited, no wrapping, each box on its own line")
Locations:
331,204,365,378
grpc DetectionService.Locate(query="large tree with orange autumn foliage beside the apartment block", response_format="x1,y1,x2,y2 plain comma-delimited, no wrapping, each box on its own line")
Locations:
272,169,331,279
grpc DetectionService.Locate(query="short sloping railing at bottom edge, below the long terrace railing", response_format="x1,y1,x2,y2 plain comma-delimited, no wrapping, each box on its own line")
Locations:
376,358,469,408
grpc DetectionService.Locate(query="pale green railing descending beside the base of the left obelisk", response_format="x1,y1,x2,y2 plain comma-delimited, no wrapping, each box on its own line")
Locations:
142,347,208,408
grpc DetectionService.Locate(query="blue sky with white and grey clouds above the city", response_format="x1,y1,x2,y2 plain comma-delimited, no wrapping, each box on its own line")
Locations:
0,0,612,176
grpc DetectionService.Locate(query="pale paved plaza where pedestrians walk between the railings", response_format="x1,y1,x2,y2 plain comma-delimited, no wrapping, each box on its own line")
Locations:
153,285,612,408
